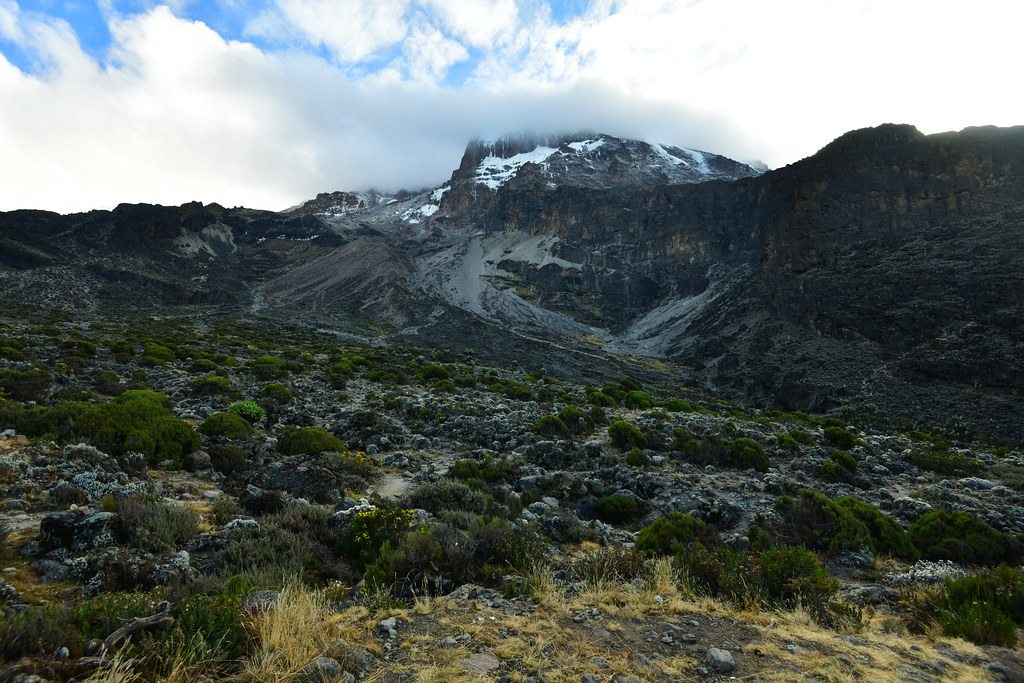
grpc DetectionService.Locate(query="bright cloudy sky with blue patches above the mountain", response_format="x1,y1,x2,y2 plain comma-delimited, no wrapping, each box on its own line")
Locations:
0,0,1024,213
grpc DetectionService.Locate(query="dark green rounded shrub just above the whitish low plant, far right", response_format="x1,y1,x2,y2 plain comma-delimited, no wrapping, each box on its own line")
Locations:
910,509,1021,565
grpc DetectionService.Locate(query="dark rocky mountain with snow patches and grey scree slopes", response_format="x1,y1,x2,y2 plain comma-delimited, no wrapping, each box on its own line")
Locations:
0,125,1024,439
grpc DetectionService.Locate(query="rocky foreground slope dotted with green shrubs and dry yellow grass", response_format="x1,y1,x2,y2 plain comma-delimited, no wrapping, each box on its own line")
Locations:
0,306,1024,683
